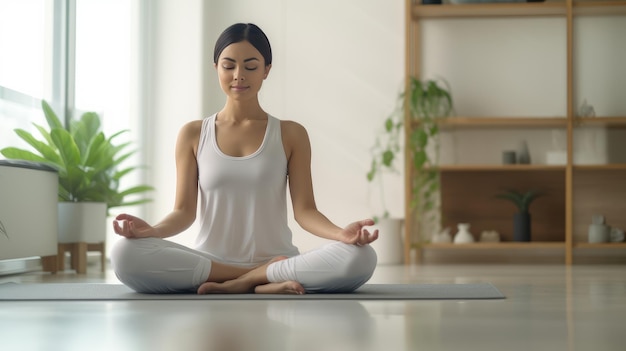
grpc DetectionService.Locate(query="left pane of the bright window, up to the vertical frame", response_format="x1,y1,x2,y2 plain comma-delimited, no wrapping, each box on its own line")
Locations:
0,0,65,147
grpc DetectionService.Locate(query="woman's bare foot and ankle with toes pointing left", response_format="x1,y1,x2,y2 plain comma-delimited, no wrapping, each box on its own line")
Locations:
198,256,287,294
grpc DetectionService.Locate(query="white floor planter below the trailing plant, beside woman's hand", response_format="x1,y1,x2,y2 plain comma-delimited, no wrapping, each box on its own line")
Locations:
371,218,404,265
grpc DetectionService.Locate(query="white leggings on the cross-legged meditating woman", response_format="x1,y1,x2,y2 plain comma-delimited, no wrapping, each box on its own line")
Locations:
111,238,376,293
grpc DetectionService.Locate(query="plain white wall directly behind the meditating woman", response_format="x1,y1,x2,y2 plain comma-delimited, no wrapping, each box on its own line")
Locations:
141,0,404,250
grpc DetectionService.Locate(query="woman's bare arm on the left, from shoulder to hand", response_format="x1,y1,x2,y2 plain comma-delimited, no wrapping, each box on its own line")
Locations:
113,121,202,238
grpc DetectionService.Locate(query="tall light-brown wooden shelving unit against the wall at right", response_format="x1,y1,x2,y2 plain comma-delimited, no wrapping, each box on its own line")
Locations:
404,0,626,265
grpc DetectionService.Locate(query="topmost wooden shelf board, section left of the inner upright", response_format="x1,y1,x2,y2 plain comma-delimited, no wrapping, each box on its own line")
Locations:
412,1,567,18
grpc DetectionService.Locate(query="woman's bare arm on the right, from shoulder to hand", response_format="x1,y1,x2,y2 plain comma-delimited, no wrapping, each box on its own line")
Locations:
281,121,378,245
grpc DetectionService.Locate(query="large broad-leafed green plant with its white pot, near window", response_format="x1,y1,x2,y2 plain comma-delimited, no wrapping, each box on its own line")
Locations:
0,101,152,242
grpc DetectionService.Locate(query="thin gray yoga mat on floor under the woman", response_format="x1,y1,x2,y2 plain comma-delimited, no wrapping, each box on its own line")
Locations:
0,283,505,301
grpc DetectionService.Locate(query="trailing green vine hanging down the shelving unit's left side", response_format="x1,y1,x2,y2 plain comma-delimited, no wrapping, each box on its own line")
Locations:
367,77,453,221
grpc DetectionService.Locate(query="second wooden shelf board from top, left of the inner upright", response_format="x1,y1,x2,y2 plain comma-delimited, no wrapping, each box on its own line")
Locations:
439,117,567,128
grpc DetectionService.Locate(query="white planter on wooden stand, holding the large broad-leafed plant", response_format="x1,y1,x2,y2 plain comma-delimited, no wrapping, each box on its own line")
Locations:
58,202,107,244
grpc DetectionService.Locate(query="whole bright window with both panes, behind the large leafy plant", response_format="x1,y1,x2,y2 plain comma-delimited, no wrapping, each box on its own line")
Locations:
0,0,140,155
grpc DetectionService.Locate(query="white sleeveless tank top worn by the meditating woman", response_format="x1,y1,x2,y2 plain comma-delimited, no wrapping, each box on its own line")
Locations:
196,114,298,267
